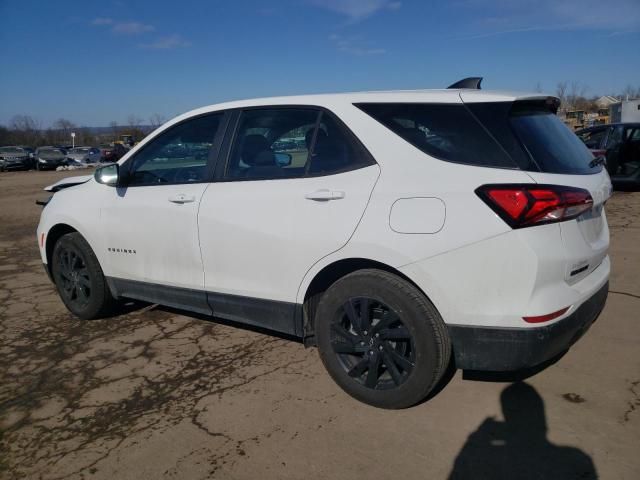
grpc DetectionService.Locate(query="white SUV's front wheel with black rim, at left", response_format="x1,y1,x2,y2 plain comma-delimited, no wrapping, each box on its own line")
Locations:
51,232,115,320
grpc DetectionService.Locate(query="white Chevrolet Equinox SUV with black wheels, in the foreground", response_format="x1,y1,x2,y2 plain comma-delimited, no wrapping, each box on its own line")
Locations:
38,81,611,408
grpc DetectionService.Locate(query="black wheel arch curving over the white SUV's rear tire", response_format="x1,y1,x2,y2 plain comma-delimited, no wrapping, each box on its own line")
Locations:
303,257,429,346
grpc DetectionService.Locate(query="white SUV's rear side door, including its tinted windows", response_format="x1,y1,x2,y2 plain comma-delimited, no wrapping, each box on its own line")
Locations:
198,107,379,334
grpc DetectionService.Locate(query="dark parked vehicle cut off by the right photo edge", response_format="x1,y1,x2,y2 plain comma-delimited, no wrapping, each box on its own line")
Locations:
576,123,640,188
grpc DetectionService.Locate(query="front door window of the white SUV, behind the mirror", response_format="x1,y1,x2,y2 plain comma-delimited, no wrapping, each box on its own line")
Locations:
129,113,223,186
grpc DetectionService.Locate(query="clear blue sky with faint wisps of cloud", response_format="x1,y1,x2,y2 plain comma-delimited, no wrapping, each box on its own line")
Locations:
0,0,640,126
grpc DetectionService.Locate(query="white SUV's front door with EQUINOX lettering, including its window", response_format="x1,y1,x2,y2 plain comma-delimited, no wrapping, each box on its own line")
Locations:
101,113,224,311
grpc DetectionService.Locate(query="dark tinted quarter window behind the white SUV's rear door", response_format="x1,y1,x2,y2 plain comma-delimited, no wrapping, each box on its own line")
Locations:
356,103,518,168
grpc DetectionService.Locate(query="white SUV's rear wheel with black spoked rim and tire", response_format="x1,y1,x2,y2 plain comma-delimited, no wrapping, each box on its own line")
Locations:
315,270,451,409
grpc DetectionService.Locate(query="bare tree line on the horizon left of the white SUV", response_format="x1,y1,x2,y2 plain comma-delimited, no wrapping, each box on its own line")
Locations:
0,113,166,147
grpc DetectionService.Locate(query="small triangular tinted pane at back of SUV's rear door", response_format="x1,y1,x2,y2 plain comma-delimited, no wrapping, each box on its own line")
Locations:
308,113,373,175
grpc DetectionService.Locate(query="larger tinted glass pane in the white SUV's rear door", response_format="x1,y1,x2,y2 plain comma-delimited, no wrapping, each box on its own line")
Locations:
225,108,319,179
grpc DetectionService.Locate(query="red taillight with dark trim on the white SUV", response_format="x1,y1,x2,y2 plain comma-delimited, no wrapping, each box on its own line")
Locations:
476,183,593,228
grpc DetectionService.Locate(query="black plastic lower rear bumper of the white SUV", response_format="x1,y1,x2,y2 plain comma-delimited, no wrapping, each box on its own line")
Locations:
448,282,609,372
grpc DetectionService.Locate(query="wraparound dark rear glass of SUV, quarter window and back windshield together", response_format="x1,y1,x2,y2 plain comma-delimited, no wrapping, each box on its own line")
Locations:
356,101,602,174
